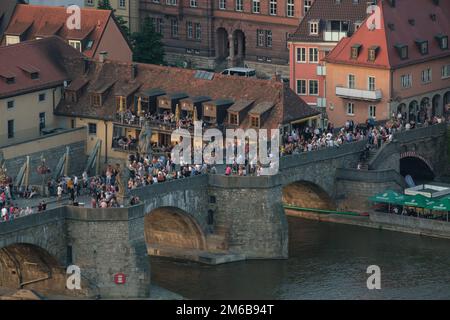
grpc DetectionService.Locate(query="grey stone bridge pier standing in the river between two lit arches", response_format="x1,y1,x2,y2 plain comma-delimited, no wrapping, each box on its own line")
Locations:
209,175,288,259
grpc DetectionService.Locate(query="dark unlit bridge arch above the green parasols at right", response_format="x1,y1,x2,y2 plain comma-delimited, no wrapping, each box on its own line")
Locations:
400,153,435,184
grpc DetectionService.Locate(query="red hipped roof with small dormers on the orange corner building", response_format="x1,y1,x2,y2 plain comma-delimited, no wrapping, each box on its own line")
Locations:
325,0,450,68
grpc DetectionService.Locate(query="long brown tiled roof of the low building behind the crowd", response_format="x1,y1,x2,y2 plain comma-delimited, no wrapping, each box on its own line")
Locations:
56,60,319,128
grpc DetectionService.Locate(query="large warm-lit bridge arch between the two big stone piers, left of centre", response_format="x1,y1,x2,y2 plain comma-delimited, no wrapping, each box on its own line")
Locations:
144,207,206,254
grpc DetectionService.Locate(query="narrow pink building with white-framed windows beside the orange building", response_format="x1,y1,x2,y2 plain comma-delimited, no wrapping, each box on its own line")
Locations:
288,0,368,125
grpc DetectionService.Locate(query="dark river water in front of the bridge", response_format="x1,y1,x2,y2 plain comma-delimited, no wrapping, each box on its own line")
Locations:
150,217,450,299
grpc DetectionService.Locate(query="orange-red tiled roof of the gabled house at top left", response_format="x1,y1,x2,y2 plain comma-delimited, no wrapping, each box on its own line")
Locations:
5,4,112,58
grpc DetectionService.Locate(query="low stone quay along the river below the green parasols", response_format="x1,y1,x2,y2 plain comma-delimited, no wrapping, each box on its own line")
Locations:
285,209,450,239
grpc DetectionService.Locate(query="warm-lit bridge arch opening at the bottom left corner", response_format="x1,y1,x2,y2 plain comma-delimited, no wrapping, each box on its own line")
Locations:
0,243,70,295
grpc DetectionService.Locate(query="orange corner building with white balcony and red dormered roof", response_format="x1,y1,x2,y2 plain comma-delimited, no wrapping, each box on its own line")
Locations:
324,0,450,126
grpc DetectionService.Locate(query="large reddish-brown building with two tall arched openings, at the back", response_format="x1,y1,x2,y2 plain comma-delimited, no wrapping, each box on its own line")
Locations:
140,0,313,77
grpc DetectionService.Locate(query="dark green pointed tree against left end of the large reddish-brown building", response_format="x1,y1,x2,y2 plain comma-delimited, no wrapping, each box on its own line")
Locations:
131,17,164,64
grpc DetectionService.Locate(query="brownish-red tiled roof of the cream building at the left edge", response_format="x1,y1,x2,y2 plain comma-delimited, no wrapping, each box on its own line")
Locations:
0,37,83,98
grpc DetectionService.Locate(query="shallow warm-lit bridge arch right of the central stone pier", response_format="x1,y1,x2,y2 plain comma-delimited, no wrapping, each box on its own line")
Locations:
282,181,337,210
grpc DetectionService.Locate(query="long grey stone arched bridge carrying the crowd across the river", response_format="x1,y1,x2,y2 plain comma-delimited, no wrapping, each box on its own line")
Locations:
0,124,448,297
